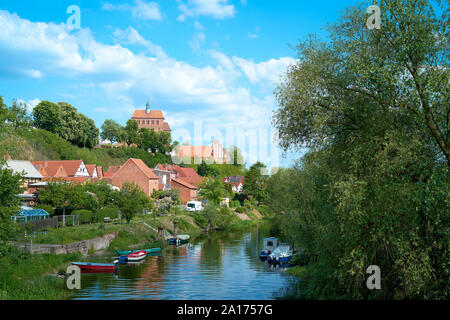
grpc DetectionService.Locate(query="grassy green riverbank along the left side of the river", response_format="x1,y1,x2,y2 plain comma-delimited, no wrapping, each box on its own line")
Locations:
0,210,264,300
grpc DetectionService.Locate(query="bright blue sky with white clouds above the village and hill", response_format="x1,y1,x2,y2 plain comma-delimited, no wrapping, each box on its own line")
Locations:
0,0,356,167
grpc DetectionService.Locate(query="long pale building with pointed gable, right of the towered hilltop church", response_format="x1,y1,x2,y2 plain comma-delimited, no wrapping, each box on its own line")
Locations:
171,140,228,164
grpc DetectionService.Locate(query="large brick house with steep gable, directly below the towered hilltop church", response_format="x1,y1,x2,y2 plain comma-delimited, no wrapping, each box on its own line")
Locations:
110,158,159,197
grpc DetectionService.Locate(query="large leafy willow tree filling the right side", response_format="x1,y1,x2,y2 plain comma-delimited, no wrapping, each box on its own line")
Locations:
269,0,450,298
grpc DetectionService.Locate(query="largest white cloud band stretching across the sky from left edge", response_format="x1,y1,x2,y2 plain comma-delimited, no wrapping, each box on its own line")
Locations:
0,11,294,151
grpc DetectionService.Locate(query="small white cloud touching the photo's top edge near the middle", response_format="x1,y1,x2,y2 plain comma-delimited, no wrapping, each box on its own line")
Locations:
178,0,236,21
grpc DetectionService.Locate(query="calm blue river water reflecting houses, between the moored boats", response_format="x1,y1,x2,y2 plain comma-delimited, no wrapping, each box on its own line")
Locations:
73,229,294,300
